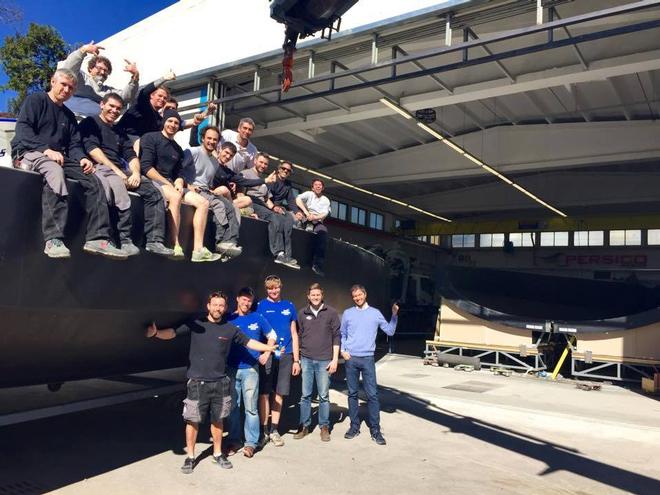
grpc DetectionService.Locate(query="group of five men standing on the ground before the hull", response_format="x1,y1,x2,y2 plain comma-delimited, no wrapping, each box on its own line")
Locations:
146,275,399,474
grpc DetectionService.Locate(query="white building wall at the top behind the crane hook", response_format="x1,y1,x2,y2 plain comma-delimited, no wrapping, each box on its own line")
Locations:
99,0,462,86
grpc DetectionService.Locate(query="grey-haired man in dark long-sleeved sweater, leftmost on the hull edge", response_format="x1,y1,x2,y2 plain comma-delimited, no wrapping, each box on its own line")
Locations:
11,69,126,259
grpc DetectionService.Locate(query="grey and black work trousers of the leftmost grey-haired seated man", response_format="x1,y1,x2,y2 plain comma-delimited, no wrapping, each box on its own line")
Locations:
21,151,110,241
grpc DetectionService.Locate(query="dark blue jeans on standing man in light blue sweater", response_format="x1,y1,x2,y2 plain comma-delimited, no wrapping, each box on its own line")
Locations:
344,356,380,435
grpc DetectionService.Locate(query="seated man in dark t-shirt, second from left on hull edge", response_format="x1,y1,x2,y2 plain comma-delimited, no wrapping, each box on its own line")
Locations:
80,93,173,256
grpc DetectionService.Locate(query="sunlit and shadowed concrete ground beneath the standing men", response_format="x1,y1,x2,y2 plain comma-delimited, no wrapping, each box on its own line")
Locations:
0,355,660,495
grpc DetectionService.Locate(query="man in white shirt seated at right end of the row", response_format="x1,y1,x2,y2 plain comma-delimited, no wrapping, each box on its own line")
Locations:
296,179,330,277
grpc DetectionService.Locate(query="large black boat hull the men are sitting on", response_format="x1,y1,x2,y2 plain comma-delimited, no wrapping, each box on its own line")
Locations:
0,168,388,387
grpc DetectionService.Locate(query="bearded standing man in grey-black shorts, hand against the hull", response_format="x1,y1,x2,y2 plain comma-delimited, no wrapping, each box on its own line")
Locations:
147,292,275,474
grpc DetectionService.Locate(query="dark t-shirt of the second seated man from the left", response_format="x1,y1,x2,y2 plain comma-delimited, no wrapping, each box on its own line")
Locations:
80,115,136,168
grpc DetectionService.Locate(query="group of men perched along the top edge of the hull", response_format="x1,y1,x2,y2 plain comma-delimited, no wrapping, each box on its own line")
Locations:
12,43,330,275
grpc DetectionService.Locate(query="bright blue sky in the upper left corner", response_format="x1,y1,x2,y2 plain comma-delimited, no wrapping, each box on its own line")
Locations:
0,0,176,112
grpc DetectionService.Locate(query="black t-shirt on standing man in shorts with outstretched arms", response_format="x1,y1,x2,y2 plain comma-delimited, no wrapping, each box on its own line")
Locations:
174,319,250,381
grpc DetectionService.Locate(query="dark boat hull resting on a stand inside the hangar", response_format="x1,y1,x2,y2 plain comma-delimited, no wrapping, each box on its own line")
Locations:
438,266,660,333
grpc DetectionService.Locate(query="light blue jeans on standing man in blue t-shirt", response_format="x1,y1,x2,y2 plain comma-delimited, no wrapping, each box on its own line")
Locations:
229,366,259,448
